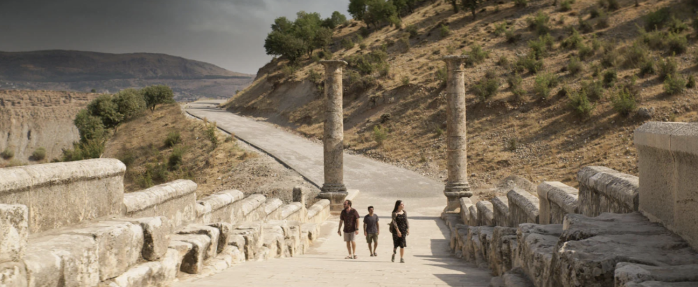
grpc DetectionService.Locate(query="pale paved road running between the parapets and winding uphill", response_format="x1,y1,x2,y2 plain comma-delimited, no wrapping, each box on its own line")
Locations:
175,101,490,287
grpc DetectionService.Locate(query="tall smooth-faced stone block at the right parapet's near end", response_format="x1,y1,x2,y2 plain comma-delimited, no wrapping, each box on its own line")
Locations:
635,122,698,253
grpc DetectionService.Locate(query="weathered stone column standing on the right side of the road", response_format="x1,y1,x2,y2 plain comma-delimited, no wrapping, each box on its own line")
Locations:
442,56,473,212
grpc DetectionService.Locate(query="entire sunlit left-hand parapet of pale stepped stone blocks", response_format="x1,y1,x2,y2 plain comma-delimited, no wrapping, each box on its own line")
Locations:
0,159,330,287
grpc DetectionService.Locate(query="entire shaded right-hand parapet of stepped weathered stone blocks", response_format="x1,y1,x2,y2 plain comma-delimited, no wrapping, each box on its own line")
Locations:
442,123,698,287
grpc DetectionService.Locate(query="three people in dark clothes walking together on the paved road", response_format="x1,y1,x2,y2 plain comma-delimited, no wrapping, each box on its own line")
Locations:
337,200,410,263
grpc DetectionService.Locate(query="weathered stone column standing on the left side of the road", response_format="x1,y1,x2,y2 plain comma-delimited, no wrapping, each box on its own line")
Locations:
318,61,348,214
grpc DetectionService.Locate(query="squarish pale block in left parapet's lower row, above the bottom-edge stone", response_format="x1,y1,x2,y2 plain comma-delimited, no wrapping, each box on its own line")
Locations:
67,221,143,281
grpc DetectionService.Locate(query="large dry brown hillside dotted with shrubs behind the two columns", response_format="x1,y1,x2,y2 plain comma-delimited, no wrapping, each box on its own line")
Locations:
224,0,698,195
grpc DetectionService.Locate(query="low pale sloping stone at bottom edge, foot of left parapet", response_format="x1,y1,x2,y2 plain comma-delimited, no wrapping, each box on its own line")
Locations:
102,249,180,287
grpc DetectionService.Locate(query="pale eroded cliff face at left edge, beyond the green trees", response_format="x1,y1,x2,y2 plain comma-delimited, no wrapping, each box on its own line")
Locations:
0,90,97,165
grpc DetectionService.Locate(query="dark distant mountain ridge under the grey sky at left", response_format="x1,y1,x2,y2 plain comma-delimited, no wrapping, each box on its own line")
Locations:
0,50,254,100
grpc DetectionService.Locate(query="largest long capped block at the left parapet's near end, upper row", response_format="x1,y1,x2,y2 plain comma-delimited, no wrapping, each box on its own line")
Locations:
0,159,126,233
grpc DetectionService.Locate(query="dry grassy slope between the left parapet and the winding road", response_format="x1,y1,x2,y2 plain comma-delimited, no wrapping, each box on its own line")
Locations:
102,104,317,202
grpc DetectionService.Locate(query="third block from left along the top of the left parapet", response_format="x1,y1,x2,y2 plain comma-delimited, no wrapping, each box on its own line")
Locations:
196,190,245,224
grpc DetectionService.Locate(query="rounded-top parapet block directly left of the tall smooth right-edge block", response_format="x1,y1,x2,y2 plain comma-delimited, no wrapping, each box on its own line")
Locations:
577,166,640,216
